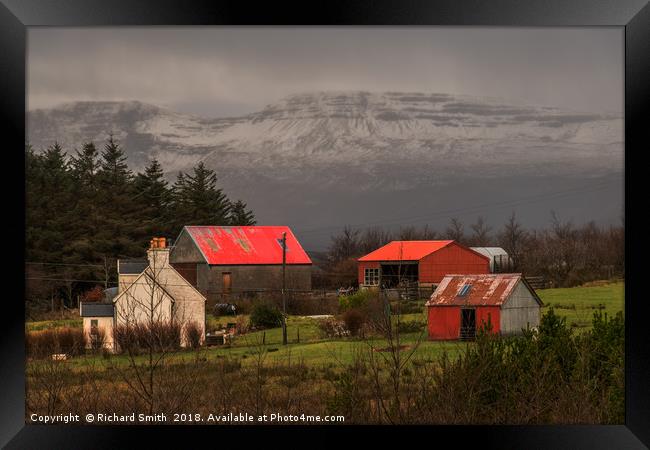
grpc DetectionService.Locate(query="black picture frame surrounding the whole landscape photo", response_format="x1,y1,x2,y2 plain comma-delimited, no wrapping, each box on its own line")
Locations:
0,0,650,449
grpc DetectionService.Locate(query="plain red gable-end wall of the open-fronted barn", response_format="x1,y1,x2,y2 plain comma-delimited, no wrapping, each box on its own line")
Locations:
419,242,490,283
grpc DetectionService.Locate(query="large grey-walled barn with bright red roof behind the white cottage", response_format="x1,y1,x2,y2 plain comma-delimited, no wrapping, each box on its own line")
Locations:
170,226,312,303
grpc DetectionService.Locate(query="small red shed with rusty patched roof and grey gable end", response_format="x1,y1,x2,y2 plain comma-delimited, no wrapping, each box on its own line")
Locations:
426,273,542,340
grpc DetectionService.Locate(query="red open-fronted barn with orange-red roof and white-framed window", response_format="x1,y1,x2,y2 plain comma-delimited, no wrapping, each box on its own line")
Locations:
358,241,490,288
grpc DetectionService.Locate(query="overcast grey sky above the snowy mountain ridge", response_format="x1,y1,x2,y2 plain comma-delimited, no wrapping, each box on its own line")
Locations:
27,27,623,117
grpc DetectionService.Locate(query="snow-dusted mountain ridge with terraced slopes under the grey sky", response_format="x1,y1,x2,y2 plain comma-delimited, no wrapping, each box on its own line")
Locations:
28,92,623,248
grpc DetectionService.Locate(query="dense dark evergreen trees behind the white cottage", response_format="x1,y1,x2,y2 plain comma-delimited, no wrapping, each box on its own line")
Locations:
25,136,255,312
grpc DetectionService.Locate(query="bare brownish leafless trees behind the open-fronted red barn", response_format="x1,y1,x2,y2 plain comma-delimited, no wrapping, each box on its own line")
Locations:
327,212,625,286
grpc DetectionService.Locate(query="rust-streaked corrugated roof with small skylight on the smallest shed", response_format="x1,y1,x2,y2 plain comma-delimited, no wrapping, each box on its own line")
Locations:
426,273,541,306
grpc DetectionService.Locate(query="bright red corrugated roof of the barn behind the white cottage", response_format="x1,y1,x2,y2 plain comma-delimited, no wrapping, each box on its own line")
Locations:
185,226,311,265
